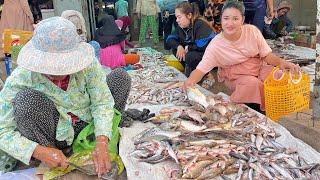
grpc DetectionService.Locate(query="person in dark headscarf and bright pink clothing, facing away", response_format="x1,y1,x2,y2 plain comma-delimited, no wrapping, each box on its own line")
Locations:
95,15,126,69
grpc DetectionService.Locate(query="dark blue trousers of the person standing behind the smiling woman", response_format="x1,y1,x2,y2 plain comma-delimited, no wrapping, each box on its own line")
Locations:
244,3,267,33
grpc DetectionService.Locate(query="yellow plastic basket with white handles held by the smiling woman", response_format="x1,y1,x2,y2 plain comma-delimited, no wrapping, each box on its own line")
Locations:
264,68,310,121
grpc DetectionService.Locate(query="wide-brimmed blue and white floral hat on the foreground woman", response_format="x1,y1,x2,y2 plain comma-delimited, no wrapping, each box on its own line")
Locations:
17,17,95,75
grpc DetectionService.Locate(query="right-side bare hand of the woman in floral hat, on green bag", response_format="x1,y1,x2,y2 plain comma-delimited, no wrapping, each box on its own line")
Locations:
92,136,111,178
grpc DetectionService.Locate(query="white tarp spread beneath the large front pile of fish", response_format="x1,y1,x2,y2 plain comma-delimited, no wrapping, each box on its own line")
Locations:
119,93,320,180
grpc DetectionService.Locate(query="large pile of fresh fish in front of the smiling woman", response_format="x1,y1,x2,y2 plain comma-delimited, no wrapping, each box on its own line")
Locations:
131,89,320,179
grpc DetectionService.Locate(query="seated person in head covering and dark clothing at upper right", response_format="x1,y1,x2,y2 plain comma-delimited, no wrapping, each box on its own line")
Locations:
263,0,293,39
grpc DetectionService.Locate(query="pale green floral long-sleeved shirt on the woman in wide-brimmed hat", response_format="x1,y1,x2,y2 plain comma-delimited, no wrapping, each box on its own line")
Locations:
0,61,114,164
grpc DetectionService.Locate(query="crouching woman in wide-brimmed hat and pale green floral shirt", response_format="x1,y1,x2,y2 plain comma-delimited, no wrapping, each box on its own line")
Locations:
0,17,129,175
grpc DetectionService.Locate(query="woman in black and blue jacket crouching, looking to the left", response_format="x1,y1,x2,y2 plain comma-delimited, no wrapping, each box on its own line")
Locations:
166,2,216,77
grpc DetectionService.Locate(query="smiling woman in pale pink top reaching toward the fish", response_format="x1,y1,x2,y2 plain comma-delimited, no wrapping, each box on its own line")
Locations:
183,1,300,110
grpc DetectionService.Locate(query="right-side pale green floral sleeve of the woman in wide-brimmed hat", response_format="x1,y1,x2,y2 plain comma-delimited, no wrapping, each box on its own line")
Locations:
85,61,114,139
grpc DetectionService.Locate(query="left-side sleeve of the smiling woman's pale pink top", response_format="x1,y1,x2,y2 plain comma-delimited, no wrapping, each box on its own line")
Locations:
197,42,218,74
